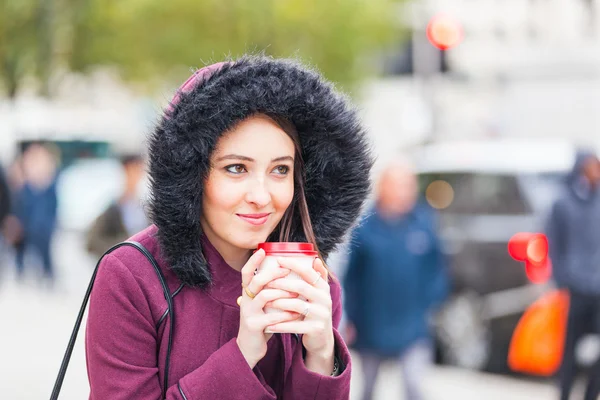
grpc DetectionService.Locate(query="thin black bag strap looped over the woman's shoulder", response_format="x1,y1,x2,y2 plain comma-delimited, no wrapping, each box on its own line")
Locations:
50,241,175,400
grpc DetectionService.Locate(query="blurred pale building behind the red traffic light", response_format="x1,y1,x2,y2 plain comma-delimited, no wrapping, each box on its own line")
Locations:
364,0,600,167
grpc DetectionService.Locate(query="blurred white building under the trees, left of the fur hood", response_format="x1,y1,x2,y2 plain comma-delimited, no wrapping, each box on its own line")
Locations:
0,71,158,163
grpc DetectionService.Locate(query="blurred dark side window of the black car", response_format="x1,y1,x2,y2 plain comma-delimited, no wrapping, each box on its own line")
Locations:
419,173,532,215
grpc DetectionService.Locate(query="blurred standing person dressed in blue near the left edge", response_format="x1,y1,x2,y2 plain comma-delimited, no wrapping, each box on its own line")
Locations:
15,143,58,283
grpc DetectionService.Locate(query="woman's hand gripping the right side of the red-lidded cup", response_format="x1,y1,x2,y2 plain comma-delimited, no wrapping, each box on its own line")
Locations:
267,257,335,375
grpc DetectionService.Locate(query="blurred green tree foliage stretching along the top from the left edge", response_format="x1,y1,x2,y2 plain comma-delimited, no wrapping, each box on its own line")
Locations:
0,0,403,98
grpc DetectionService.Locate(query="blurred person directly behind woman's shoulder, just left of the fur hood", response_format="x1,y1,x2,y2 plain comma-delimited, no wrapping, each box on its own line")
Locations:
87,154,149,258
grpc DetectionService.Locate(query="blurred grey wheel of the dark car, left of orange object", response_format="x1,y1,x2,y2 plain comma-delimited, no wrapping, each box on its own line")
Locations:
435,292,491,370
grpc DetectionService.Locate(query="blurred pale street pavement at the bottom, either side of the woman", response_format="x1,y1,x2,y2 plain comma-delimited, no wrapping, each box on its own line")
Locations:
0,234,572,400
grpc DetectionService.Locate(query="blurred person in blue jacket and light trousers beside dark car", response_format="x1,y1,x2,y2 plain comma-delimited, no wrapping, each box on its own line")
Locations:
344,162,448,400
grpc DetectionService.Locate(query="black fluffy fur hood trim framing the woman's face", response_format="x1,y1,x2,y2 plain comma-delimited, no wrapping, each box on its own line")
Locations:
149,56,373,287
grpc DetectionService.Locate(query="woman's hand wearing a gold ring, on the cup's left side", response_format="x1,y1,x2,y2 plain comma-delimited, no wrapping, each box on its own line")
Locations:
237,249,298,368
